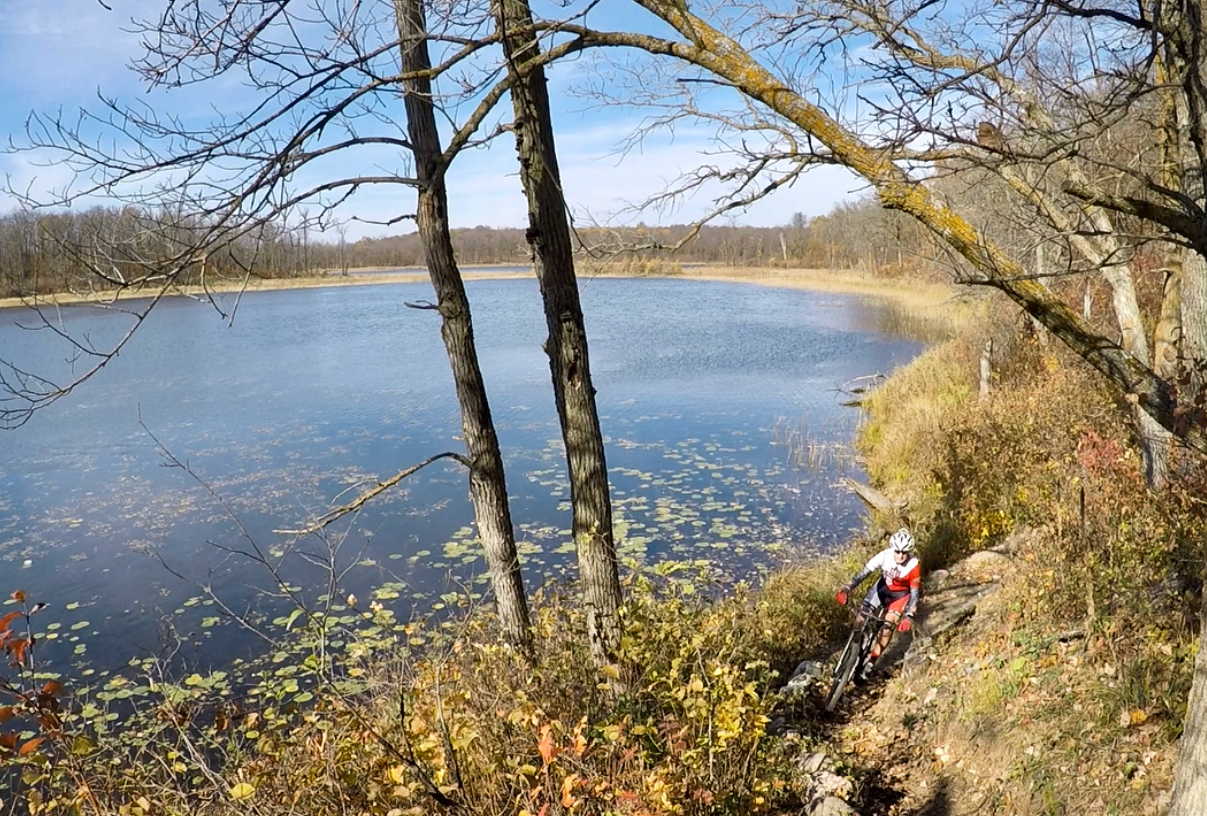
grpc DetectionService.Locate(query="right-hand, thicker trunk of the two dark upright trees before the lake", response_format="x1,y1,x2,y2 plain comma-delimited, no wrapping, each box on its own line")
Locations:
491,0,622,667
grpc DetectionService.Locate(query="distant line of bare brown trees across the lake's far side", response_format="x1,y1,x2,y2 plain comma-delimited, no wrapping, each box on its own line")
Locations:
0,198,933,297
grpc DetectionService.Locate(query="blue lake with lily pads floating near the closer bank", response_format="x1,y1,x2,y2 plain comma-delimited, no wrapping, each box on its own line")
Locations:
0,279,922,672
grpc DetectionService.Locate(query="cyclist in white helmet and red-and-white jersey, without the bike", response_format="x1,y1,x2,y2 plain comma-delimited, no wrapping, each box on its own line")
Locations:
834,527,922,678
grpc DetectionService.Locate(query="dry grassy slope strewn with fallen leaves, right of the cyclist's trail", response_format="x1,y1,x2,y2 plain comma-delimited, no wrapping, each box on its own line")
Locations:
871,564,1191,815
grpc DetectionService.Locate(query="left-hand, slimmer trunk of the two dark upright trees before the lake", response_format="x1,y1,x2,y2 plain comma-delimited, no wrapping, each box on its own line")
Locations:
395,0,532,655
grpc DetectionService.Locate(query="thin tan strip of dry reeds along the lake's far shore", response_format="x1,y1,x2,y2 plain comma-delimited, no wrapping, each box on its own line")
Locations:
0,263,957,309
